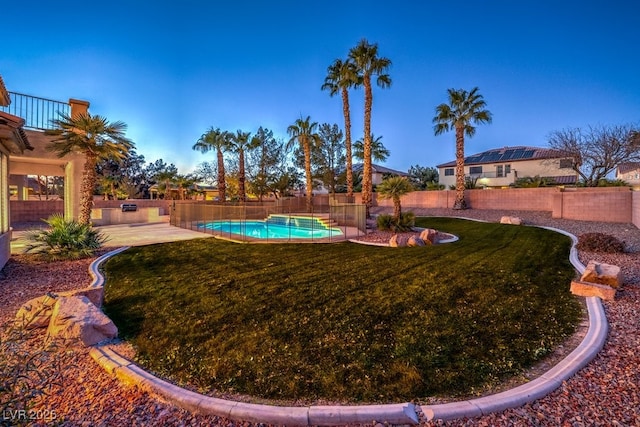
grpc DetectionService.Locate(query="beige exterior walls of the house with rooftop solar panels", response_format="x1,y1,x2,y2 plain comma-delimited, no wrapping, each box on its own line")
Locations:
438,159,576,188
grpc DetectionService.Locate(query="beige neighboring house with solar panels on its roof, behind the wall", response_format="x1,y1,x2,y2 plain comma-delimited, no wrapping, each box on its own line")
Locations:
437,146,578,188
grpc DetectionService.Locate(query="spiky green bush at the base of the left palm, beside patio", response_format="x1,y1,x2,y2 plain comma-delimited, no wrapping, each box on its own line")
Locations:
26,214,107,261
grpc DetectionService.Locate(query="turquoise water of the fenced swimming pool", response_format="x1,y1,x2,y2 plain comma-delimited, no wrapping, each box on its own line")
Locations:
199,218,343,239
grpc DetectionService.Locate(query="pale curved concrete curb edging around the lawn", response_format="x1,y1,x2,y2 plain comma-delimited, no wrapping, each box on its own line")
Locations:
89,218,608,426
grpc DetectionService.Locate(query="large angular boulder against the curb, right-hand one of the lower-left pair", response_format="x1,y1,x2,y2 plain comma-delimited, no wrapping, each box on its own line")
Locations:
47,296,118,346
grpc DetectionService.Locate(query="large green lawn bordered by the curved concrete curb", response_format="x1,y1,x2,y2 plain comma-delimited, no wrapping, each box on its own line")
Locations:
104,218,580,402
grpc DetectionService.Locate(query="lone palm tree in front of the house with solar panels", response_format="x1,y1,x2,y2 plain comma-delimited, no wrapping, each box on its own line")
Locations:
433,87,491,209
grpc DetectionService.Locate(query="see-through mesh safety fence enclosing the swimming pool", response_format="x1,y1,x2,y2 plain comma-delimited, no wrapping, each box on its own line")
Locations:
170,197,366,243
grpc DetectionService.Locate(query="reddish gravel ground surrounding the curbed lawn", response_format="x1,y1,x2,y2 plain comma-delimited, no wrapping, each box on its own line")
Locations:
0,209,640,427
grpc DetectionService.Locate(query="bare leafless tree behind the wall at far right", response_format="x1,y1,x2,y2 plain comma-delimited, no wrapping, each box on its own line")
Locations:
548,125,640,187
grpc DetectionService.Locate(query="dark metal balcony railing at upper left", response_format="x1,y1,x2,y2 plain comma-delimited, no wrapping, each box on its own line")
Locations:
0,92,71,130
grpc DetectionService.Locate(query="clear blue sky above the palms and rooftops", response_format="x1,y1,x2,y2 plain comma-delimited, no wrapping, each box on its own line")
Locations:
0,0,640,173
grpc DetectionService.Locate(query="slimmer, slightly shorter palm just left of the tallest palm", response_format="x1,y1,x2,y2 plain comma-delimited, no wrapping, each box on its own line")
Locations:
321,59,360,197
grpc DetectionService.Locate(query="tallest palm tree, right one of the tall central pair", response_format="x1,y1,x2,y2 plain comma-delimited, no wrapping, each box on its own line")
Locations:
349,39,391,218
